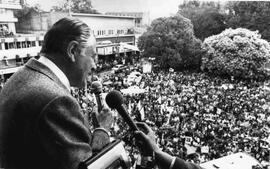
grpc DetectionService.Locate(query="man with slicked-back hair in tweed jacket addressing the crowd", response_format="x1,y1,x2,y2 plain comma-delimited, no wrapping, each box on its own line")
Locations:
0,18,112,169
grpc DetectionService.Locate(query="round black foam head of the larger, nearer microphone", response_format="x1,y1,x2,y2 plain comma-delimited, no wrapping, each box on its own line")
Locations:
105,90,124,109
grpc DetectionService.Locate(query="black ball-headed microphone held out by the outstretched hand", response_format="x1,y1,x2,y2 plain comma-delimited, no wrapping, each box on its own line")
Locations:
105,90,139,131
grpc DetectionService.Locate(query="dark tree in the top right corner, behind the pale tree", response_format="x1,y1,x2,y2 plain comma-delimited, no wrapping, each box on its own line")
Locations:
226,1,270,41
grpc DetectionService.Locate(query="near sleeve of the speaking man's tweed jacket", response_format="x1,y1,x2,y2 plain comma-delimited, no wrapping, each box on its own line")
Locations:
37,96,92,169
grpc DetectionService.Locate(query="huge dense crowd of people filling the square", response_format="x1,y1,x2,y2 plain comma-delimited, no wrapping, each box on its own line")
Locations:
70,63,270,168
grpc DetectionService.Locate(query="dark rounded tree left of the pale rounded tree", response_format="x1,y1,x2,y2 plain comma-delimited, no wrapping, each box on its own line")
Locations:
138,15,201,70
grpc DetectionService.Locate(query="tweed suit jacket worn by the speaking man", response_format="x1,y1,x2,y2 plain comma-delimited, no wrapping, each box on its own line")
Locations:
0,59,105,169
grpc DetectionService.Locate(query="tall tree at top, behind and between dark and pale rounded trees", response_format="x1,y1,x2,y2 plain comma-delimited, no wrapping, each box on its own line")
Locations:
178,0,227,40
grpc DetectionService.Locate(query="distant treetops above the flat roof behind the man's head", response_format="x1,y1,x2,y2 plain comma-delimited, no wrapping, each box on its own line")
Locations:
52,0,99,14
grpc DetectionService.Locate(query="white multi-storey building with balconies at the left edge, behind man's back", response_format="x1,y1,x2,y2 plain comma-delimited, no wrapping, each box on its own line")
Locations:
0,0,43,82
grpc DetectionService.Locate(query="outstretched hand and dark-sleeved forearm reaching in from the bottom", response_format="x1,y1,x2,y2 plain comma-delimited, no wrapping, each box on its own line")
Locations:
135,122,202,169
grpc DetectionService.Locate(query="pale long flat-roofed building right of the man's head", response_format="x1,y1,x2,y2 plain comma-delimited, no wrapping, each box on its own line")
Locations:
72,13,135,55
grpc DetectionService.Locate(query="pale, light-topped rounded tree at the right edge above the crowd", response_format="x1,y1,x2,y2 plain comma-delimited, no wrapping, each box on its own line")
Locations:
202,28,270,79
